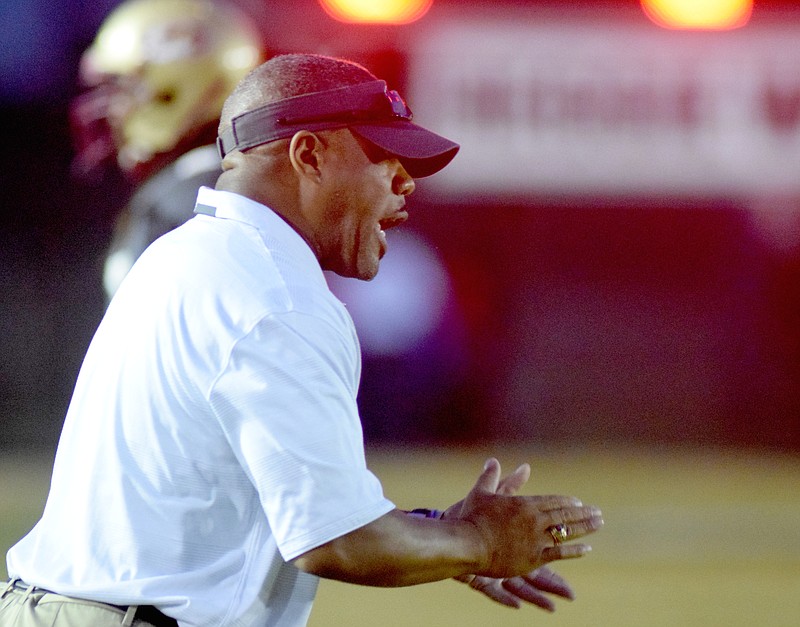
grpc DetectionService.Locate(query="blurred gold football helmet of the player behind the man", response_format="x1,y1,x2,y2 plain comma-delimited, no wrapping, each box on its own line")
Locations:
73,0,263,178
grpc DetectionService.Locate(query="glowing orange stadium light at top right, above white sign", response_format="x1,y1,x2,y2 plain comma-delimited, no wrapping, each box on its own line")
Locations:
641,0,753,30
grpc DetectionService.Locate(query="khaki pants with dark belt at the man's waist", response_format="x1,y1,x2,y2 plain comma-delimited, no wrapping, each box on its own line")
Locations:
0,582,159,627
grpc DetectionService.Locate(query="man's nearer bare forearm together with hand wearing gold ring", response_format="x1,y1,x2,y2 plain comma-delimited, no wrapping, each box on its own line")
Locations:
294,458,603,587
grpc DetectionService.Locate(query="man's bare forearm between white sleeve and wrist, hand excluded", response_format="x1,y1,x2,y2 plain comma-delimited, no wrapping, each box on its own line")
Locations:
294,510,487,587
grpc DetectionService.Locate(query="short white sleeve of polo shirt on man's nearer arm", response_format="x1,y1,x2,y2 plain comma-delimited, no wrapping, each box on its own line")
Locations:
210,312,394,560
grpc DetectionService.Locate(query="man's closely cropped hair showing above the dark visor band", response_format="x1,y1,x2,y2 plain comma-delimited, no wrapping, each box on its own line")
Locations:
219,54,377,132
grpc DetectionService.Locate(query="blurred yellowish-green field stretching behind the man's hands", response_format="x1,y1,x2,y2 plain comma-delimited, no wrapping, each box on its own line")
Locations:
0,446,800,627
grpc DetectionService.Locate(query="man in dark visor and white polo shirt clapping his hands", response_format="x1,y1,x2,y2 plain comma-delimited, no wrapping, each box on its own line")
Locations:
0,55,602,626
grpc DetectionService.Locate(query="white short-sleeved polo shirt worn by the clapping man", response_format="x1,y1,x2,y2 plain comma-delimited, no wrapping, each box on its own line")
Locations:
8,188,394,627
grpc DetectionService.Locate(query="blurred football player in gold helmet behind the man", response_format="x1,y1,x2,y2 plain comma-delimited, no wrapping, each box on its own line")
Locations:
71,0,265,300
